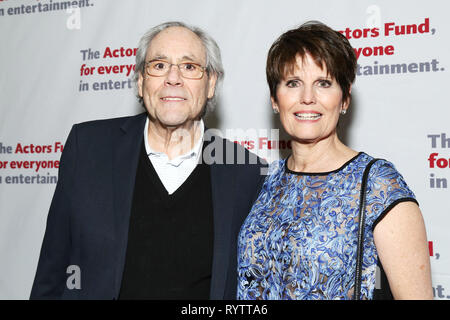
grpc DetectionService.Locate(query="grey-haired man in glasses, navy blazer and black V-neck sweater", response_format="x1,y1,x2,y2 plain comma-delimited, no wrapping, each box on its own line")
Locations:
31,22,263,299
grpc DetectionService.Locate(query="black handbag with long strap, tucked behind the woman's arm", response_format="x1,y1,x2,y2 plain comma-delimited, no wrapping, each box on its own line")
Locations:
354,159,393,300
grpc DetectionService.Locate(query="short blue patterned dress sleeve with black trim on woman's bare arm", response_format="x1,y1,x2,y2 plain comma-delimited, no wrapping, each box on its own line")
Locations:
366,160,418,230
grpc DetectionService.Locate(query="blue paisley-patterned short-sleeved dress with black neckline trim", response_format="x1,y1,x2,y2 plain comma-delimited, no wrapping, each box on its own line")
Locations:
237,152,417,300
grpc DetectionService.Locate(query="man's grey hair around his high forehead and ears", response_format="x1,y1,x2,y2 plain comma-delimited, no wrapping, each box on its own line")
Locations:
133,21,224,116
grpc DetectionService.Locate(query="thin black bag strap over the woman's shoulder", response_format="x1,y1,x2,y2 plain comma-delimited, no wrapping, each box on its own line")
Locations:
354,159,380,300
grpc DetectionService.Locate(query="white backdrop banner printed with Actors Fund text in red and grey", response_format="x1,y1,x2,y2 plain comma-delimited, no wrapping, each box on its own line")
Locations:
0,0,450,299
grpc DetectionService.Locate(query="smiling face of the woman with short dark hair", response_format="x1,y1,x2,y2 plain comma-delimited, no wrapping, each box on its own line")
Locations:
272,54,348,143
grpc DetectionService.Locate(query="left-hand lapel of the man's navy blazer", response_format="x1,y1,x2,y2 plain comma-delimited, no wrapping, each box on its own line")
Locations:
112,113,147,298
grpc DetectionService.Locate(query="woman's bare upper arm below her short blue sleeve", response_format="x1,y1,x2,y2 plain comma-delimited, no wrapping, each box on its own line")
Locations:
374,201,433,299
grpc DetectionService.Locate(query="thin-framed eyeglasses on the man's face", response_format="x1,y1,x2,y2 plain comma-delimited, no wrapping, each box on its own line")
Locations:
145,60,206,79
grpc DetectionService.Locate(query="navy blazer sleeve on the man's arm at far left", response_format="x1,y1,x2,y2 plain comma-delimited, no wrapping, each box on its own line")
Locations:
30,125,77,299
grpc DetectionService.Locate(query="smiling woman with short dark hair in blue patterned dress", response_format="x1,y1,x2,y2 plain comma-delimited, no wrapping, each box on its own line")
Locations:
238,22,432,299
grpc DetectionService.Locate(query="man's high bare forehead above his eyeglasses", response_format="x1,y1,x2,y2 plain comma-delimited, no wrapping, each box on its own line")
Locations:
146,27,206,63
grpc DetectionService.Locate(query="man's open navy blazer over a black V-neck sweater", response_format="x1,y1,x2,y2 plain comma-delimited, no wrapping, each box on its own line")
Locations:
31,113,264,299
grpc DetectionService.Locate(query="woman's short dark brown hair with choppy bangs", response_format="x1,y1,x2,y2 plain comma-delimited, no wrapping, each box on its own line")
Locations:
266,21,356,101
